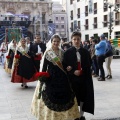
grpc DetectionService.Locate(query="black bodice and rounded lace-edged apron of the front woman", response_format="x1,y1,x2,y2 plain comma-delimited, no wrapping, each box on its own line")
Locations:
42,50,75,112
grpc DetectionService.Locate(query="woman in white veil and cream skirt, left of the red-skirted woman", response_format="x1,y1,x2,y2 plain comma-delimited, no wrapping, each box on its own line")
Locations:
5,40,17,73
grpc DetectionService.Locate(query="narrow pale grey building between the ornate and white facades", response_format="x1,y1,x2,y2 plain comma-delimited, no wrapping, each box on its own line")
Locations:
52,2,68,38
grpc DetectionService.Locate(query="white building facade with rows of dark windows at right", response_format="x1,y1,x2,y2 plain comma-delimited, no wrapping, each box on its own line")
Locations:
66,0,120,40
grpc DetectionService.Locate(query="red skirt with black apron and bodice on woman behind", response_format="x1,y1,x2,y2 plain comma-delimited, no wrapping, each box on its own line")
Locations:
11,46,36,83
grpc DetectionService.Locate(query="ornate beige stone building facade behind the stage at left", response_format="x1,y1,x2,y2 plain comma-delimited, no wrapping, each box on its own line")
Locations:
0,0,52,40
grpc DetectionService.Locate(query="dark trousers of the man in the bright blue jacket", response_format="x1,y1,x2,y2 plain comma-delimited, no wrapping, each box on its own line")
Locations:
97,55,105,78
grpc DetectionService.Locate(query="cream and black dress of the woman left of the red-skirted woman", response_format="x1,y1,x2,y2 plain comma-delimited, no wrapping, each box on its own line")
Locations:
5,45,16,73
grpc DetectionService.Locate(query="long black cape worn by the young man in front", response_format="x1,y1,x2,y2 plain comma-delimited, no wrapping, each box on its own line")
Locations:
63,47,94,114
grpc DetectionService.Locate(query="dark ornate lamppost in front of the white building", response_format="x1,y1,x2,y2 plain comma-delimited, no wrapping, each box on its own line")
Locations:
104,0,119,39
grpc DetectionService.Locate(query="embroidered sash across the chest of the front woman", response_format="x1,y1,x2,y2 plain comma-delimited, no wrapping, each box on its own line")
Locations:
47,50,66,74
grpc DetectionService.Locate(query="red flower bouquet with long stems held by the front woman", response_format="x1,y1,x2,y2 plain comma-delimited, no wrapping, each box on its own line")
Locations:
35,72,50,99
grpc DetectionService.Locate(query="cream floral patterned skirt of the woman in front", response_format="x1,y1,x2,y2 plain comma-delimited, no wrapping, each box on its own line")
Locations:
31,81,80,120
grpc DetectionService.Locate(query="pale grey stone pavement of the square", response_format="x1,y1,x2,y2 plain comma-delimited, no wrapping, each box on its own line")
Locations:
0,59,120,120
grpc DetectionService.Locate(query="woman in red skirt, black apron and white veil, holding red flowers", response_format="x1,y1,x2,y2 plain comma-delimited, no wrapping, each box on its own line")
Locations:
11,38,36,88
